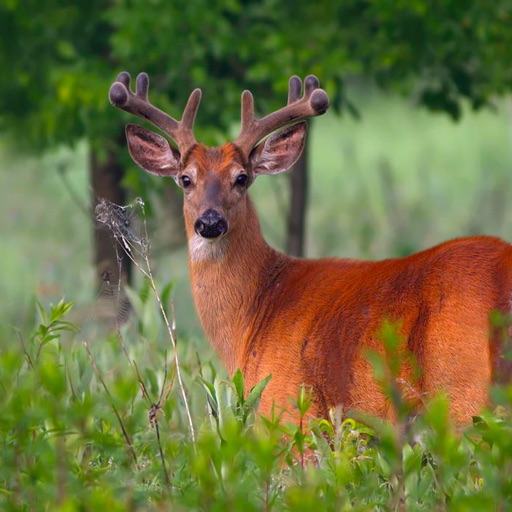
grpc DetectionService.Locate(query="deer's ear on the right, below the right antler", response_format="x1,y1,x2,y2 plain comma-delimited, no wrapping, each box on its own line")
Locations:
249,121,307,175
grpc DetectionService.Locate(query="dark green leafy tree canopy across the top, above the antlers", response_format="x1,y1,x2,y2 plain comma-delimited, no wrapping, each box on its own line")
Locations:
4,0,512,149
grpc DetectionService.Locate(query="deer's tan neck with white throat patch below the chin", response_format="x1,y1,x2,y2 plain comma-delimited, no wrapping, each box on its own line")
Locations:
187,197,282,375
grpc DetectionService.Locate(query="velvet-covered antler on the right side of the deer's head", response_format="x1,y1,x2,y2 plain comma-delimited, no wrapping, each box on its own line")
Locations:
234,75,329,156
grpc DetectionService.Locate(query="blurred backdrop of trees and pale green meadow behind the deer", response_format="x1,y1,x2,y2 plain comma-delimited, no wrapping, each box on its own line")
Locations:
0,0,512,339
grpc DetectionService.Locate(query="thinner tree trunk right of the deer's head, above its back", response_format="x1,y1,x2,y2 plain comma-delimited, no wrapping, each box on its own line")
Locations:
286,136,311,257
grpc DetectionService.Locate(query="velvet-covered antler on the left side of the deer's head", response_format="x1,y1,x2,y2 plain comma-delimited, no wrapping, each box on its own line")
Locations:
108,71,201,154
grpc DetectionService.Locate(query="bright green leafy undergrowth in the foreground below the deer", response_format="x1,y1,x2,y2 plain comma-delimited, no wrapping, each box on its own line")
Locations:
0,302,512,511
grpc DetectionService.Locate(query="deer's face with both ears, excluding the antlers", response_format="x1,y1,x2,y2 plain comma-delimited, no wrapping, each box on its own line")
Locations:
126,122,306,250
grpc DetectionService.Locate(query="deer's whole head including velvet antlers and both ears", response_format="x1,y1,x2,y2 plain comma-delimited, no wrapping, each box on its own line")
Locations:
109,72,329,254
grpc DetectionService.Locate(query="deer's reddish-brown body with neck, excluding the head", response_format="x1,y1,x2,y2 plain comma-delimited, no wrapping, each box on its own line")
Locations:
189,190,512,423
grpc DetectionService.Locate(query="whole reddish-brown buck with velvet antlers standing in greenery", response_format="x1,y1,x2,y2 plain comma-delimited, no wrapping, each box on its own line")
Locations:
109,72,512,425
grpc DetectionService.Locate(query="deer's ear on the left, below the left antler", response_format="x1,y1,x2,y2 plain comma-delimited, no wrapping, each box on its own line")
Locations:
126,124,181,178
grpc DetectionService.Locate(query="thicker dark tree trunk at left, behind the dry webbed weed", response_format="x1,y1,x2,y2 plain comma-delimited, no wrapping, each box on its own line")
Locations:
89,146,131,293
